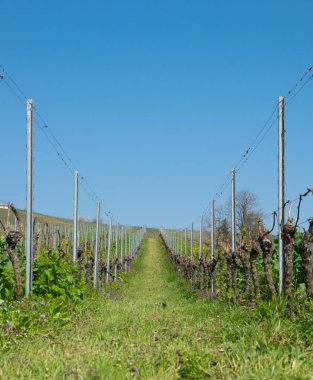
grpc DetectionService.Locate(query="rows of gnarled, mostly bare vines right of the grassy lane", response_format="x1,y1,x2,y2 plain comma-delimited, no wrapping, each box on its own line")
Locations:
161,189,313,302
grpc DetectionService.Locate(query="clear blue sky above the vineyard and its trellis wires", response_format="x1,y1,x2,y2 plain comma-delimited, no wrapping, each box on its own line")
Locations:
0,0,313,227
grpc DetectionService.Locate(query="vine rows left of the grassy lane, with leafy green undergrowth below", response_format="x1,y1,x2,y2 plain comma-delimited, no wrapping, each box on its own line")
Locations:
0,203,145,354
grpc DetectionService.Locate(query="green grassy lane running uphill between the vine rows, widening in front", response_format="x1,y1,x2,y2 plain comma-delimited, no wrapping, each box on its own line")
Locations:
0,238,313,379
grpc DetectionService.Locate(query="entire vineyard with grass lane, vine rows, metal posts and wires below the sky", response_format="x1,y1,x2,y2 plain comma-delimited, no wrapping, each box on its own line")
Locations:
0,67,313,379
